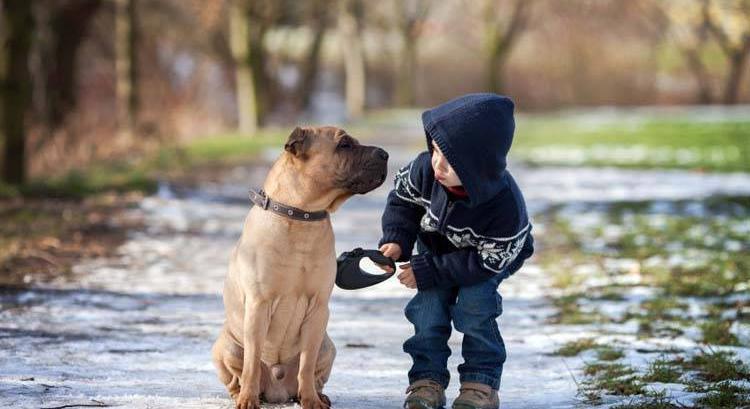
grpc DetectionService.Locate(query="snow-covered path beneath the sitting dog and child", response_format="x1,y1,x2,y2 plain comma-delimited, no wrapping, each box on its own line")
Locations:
0,129,750,409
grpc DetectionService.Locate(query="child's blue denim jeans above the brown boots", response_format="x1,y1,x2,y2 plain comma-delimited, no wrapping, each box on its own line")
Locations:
404,274,505,389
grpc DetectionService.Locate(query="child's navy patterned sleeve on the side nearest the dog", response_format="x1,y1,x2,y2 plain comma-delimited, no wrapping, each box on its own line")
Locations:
378,155,425,261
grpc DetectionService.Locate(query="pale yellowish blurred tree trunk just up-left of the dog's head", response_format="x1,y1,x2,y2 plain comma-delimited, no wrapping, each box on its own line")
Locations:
229,0,259,134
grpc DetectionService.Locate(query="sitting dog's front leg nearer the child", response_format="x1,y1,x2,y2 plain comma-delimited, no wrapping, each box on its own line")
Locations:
297,303,330,409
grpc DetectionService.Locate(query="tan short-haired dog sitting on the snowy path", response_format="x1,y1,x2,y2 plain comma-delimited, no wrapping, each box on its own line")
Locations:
213,127,388,409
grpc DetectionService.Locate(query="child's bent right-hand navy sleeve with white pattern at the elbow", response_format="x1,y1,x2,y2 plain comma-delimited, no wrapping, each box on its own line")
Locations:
411,224,534,290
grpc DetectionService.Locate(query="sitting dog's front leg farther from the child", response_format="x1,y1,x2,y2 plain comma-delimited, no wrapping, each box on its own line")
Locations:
236,298,270,409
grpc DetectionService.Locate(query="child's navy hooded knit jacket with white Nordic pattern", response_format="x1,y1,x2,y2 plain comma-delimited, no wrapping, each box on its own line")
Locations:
379,94,534,290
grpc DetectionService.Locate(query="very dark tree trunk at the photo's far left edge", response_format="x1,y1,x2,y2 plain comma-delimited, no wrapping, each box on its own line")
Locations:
0,0,34,185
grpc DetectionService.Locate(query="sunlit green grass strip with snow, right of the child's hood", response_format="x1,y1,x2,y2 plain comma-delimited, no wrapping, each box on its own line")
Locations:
511,115,750,172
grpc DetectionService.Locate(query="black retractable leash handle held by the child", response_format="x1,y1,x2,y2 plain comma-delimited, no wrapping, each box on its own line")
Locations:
336,247,396,290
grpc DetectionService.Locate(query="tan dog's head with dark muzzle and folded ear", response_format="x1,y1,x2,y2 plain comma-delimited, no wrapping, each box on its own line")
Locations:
284,126,388,194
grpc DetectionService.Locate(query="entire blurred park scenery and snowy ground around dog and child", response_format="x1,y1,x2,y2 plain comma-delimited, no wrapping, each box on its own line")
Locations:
0,0,750,409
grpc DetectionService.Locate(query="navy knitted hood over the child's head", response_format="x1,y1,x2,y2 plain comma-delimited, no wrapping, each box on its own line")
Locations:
422,93,515,207
